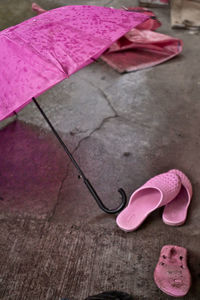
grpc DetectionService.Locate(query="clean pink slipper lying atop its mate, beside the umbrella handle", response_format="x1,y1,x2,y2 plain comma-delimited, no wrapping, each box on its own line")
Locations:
116,172,181,231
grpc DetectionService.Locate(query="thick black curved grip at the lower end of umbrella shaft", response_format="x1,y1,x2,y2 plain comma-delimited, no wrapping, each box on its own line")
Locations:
83,177,127,214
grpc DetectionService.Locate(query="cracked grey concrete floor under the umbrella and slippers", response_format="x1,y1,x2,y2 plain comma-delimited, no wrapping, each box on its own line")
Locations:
0,0,200,300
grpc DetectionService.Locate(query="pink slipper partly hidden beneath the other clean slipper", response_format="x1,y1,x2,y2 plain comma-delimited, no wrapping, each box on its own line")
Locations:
162,170,192,226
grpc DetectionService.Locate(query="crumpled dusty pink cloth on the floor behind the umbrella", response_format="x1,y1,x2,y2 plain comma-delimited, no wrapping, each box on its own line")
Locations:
101,7,182,73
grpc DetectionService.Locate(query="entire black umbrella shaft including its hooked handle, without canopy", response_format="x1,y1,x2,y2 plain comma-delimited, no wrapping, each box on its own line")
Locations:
32,98,127,214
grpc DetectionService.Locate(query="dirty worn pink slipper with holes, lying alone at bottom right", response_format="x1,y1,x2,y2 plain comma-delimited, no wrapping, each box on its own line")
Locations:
154,245,191,297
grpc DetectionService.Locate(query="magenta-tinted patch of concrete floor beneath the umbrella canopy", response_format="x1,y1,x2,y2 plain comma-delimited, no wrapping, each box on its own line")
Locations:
0,121,69,219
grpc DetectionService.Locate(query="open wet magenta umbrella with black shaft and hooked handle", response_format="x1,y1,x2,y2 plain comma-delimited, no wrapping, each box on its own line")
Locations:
0,6,148,213
